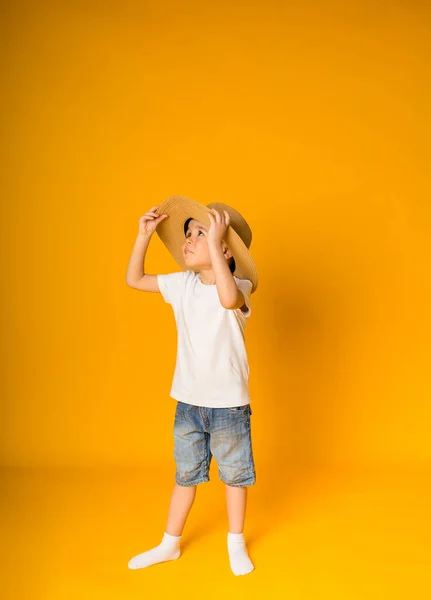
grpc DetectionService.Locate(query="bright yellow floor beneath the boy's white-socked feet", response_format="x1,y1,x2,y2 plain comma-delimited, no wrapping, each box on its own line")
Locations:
1,463,431,600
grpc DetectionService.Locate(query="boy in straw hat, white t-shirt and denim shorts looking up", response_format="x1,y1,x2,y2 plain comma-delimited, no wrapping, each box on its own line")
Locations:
127,196,258,575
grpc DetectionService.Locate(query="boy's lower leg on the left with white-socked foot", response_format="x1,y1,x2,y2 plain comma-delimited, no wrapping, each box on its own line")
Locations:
129,483,197,569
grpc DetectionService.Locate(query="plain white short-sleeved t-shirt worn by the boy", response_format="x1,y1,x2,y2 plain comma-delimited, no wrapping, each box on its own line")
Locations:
157,270,252,408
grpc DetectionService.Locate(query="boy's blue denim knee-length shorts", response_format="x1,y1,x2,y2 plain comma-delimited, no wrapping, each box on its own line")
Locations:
174,401,256,487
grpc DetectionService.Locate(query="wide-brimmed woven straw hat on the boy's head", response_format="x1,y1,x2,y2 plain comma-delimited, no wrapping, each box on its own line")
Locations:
156,196,258,293
